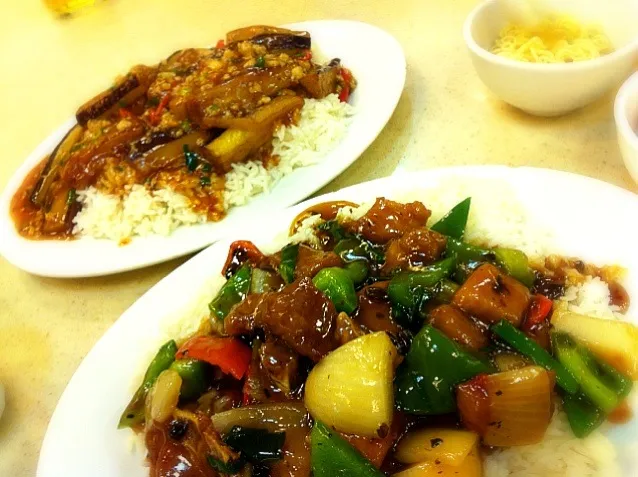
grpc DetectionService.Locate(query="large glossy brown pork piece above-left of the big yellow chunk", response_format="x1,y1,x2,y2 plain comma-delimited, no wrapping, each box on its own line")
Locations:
225,278,339,361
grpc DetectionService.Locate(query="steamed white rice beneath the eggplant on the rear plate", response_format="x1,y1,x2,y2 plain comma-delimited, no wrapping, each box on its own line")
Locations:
73,94,354,242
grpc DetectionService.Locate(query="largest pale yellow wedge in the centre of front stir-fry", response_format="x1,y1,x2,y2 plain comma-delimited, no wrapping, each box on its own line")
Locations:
304,331,397,437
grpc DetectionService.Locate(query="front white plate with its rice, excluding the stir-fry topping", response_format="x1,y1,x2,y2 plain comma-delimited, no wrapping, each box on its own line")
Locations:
37,167,638,477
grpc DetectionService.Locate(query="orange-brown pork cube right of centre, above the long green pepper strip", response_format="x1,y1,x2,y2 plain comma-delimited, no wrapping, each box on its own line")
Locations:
452,263,530,327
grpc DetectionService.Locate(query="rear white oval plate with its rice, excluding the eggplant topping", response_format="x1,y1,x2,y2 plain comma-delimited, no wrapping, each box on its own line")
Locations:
0,21,406,277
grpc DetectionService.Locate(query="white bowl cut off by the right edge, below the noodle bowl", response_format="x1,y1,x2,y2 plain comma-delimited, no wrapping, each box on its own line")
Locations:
614,72,638,182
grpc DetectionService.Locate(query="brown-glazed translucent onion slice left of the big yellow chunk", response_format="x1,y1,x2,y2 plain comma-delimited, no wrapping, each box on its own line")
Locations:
211,402,308,434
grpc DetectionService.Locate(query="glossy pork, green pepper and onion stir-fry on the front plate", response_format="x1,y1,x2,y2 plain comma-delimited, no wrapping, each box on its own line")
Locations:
119,198,638,477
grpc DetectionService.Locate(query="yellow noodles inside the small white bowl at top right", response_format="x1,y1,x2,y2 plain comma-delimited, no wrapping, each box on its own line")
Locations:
492,15,613,63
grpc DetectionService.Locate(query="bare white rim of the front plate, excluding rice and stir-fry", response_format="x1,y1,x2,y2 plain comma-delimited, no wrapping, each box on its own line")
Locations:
37,167,638,477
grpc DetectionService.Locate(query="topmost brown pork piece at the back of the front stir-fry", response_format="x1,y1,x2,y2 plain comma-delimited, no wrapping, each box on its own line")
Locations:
343,197,431,243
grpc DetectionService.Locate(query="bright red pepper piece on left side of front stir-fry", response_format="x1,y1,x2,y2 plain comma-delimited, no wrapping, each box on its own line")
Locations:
175,336,252,379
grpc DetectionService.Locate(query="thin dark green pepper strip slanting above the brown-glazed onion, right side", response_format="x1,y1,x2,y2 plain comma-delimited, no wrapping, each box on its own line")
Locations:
490,320,580,394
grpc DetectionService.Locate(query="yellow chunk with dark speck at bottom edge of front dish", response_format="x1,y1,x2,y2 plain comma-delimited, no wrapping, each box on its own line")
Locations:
394,428,478,466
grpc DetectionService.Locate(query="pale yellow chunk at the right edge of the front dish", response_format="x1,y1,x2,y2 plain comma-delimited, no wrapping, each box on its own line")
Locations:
552,309,638,381
